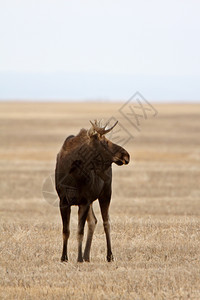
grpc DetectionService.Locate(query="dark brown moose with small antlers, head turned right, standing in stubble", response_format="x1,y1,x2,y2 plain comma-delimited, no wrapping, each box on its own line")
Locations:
55,120,130,262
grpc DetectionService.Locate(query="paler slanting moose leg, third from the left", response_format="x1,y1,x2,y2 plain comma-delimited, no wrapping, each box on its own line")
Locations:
83,204,97,262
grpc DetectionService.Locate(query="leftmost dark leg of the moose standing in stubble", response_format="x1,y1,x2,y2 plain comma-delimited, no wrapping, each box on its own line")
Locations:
60,206,71,261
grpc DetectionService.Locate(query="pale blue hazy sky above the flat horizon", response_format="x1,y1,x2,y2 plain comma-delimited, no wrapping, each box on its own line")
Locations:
0,0,200,101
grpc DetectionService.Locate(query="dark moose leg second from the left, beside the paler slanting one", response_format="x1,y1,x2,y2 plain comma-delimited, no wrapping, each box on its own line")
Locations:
77,204,89,262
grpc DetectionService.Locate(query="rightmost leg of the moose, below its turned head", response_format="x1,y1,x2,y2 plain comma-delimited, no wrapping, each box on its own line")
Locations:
99,199,114,262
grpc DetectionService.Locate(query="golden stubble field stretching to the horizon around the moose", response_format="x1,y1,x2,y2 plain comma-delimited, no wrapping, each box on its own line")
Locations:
0,102,200,300
